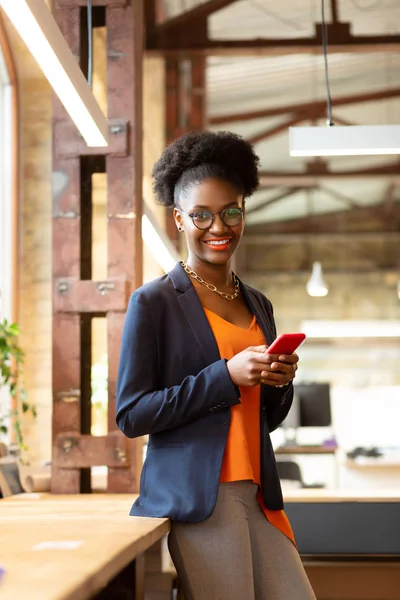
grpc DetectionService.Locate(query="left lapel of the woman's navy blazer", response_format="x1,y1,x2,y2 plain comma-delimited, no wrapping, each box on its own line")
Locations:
169,263,221,365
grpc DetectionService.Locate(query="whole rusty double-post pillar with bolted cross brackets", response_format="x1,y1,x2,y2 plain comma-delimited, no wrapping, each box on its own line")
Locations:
52,0,143,493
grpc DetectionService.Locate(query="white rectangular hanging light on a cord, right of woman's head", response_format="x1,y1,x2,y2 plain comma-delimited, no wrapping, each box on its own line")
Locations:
289,125,400,156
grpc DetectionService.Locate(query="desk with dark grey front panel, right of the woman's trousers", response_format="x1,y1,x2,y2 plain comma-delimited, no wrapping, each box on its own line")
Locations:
284,489,400,600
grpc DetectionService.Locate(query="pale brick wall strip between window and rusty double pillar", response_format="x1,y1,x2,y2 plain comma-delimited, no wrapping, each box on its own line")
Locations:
19,78,52,461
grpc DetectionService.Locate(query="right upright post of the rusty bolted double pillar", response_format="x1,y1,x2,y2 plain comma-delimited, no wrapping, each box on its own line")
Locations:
106,0,144,492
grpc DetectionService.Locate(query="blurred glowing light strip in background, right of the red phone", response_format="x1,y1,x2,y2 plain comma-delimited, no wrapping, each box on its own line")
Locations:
300,320,400,339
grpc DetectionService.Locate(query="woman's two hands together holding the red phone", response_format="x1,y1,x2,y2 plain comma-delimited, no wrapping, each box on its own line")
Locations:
226,346,299,387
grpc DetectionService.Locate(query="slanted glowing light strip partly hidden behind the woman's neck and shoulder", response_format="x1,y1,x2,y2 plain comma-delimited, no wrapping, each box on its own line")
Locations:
142,206,180,273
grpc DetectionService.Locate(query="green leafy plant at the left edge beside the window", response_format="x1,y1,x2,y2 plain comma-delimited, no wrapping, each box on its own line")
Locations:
0,319,36,453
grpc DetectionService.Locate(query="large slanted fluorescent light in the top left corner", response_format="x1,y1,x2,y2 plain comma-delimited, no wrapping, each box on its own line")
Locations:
0,0,108,147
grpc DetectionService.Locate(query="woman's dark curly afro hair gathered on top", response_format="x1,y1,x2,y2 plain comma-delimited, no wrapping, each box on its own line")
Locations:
152,131,260,206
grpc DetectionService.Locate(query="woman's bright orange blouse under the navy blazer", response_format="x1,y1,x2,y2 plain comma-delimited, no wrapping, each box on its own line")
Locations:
204,308,296,544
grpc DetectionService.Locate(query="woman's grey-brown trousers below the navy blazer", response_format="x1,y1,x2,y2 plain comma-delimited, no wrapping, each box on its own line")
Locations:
168,481,316,600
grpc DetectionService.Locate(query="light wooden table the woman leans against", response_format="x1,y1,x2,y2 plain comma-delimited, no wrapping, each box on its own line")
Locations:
0,494,170,600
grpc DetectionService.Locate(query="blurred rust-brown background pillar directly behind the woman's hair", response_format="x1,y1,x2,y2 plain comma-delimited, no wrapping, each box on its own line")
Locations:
165,56,206,243
